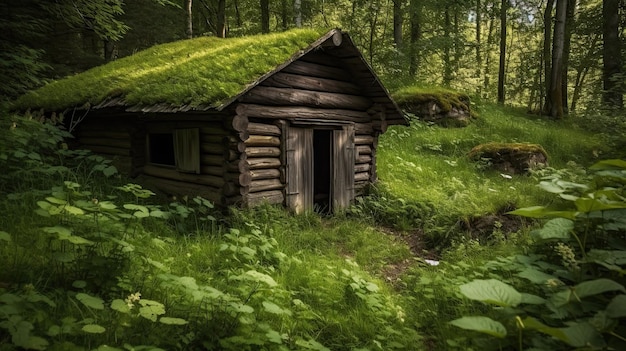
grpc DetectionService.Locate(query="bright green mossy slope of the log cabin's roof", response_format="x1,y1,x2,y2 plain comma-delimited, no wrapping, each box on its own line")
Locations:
13,29,324,111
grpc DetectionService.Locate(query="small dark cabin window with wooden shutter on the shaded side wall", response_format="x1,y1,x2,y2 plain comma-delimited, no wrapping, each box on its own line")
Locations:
148,128,200,173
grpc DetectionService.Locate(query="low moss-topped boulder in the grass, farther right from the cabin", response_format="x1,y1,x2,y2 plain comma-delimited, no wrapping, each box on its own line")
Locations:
468,143,548,174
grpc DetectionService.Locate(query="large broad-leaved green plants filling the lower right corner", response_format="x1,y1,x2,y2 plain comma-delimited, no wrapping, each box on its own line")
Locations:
451,160,626,350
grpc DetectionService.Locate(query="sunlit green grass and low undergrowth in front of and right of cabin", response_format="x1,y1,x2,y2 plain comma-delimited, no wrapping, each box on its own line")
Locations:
0,105,616,350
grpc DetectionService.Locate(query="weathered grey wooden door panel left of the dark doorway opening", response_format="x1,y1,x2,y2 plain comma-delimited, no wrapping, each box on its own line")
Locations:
285,127,313,213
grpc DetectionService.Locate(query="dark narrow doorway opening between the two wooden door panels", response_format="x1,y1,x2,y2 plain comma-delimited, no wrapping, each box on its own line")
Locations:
313,129,333,213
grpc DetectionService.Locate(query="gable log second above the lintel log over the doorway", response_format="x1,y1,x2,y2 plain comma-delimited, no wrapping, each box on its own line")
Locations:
263,72,362,95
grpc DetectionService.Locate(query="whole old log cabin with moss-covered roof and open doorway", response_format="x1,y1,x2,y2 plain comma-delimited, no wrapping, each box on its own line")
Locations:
14,29,408,212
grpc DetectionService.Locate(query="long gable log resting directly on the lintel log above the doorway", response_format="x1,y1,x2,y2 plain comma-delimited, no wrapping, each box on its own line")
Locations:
239,86,372,111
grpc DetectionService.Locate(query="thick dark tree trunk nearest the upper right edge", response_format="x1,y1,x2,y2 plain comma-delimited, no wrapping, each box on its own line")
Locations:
602,0,624,109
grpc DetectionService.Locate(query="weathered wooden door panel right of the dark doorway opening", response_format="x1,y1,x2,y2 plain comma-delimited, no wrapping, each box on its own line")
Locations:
331,125,354,211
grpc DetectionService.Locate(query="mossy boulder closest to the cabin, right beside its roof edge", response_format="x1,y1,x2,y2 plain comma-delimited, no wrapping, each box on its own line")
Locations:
393,87,476,127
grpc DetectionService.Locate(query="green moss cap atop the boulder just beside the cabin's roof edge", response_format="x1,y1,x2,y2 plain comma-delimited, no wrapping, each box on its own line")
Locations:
392,86,469,112
